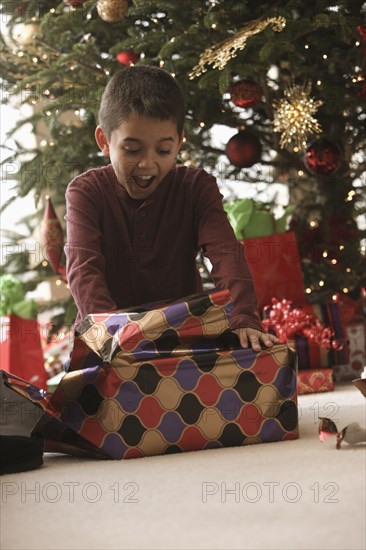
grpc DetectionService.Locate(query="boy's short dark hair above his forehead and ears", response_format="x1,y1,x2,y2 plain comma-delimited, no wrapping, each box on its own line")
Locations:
99,65,185,139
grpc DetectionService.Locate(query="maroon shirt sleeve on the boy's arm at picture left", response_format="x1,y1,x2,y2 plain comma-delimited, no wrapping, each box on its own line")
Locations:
65,175,117,322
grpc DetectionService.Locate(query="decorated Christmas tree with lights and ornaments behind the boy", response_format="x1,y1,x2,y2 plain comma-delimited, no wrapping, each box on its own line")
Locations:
0,0,366,332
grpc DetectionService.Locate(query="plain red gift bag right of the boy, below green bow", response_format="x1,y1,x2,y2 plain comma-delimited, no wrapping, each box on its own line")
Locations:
240,231,305,310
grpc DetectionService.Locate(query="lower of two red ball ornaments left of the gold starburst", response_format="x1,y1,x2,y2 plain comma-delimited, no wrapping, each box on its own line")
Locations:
226,130,262,168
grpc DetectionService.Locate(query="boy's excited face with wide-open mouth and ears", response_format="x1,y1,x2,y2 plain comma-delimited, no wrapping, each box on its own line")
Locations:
95,115,183,200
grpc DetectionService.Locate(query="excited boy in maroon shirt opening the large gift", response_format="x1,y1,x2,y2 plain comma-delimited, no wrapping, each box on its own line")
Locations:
65,66,278,351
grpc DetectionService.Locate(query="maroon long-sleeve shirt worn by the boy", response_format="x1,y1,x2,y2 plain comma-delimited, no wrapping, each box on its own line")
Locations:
65,164,262,330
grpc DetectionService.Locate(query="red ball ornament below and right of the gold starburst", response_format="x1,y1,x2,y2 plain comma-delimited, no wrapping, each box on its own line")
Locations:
305,138,342,176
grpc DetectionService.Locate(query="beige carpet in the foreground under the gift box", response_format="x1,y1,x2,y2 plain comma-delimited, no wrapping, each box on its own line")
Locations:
1,383,366,550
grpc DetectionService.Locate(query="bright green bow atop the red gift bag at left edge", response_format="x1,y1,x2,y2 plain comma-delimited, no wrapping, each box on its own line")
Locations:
0,274,37,319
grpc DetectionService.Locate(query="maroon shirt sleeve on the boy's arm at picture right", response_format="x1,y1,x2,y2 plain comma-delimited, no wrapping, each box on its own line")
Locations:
195,172,263,331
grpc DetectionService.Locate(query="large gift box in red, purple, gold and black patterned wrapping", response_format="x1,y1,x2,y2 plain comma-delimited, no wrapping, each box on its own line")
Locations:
2,291,298,459
